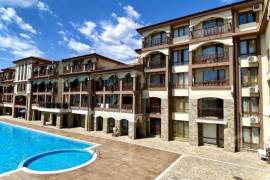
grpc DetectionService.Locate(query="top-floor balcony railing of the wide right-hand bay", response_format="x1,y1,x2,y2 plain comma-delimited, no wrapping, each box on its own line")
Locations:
191,23,232,39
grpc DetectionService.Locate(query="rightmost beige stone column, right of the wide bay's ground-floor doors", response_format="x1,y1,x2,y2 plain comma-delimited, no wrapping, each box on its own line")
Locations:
223,100,235,152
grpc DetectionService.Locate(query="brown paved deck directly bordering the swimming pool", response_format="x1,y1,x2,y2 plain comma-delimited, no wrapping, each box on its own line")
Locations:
1,119,181,180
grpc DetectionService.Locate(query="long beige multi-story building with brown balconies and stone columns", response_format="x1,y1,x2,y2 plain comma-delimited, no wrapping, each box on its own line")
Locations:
0,0,270,151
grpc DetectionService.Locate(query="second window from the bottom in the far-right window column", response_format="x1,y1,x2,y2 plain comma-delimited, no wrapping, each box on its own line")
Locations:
242,97,259,117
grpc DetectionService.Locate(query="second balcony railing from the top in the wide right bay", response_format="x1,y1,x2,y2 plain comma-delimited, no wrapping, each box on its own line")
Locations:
192,52,229,64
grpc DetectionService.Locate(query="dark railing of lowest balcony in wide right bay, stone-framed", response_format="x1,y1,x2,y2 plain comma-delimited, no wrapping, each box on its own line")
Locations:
198,108,223,119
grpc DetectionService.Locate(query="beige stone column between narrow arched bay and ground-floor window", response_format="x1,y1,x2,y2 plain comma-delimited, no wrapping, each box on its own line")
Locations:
161,98,170,141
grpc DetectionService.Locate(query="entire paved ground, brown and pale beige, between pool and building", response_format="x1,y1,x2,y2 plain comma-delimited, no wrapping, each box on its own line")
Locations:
0,116,270,180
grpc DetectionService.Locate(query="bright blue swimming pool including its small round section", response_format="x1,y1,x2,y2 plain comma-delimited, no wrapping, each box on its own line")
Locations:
0,122,95,175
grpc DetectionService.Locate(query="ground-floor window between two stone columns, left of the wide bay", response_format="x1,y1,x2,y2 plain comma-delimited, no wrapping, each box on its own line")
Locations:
173,120,189,138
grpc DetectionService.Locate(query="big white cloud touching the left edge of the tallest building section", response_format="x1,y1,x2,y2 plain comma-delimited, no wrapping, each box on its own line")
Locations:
70,5,142,62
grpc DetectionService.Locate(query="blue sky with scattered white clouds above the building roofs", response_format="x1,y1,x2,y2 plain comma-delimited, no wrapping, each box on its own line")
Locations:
0,0,240,69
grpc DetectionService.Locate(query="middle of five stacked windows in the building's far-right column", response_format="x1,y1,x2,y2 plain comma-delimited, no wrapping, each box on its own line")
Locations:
241,67,258,87
